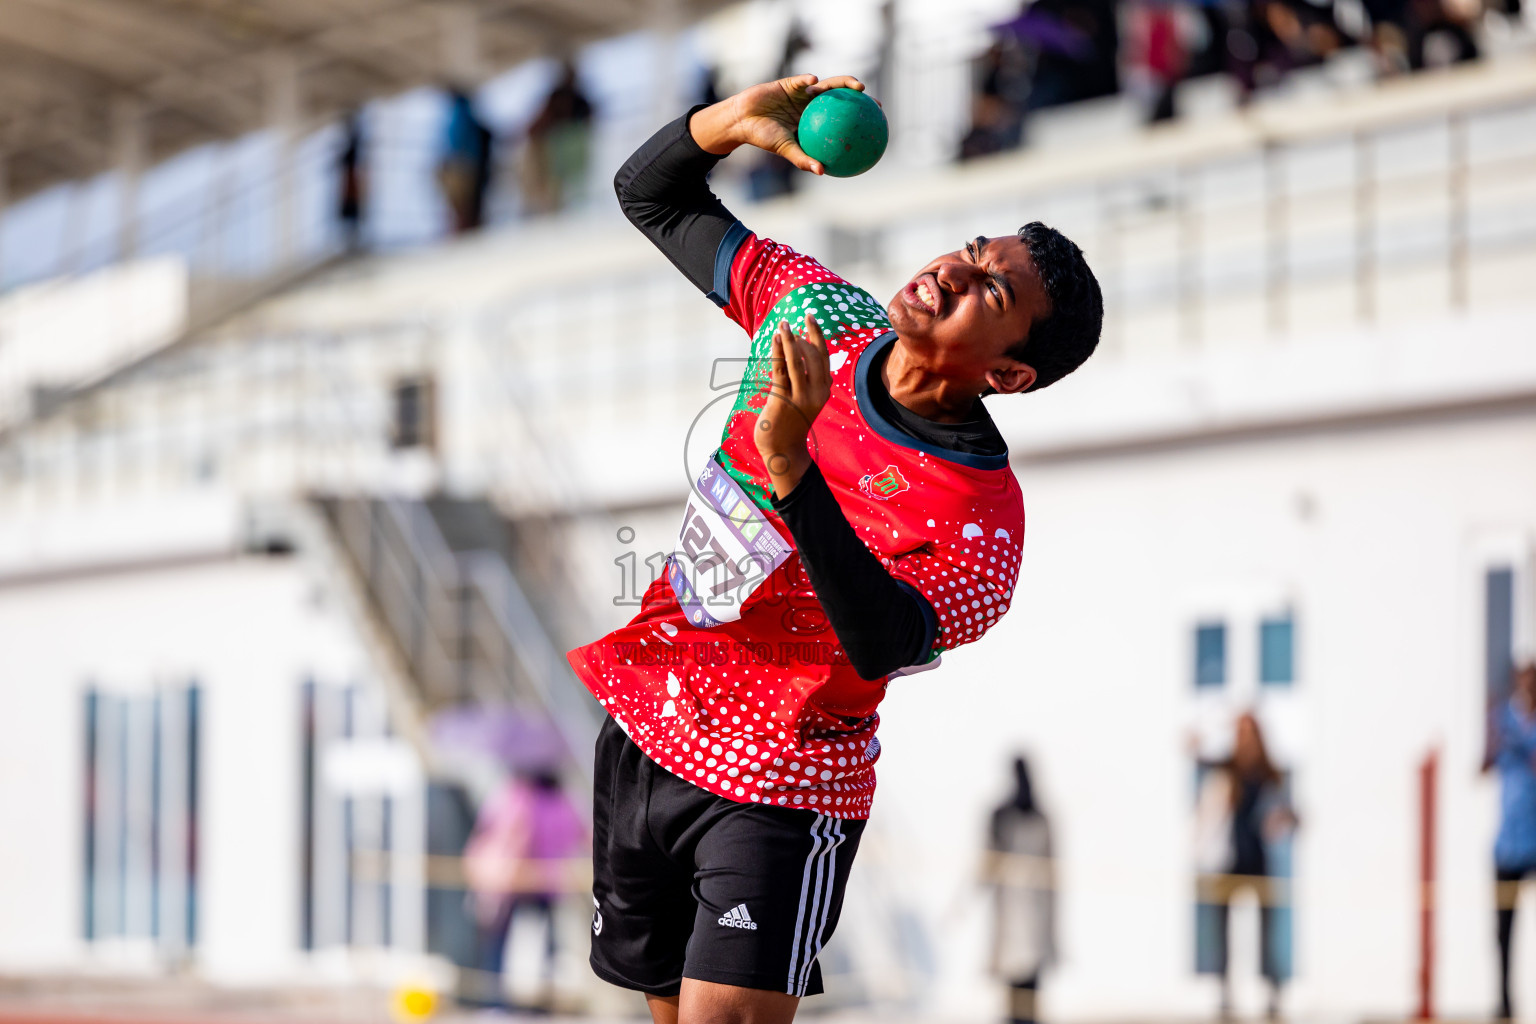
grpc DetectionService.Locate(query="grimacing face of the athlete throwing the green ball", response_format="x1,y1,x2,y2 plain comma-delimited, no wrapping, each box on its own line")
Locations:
886,235,1051,395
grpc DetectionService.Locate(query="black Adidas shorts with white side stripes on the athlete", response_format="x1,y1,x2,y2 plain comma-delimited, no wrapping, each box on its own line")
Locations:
591,718,865,995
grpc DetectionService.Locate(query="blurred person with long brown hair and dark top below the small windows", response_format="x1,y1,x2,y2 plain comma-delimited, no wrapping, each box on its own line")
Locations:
1195,714,1296,1019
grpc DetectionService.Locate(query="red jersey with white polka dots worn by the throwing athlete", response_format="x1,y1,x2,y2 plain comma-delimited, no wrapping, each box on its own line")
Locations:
570,235,1025,818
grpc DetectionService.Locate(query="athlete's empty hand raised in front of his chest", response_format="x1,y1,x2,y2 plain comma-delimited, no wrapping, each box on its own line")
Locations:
753,313,833,500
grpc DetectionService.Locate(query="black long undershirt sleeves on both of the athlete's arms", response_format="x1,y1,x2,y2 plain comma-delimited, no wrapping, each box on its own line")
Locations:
613,107,937,680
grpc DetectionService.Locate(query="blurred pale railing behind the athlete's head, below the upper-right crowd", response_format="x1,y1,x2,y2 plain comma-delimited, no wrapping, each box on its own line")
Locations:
811,57,1536,352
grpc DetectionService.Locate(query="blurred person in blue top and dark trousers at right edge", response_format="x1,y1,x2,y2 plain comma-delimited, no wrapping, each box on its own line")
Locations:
1482,662,1536,1019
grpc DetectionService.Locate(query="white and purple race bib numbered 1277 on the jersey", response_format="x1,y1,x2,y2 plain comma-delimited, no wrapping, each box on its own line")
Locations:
667,456,794,629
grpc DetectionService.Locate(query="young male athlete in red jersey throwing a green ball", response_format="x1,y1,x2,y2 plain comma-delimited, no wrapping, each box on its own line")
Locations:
570,75,1103,1024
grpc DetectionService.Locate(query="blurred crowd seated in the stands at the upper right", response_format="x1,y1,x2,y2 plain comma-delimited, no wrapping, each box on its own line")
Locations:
958,0,1522,160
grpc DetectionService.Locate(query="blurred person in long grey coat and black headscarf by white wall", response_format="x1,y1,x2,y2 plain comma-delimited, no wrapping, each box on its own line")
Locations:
983,757,1055,1024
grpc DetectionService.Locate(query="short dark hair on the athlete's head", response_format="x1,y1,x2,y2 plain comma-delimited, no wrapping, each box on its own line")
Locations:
1008,221,1104,391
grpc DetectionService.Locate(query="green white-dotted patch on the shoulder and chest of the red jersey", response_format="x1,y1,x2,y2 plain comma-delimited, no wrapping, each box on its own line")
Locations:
716,281,891,508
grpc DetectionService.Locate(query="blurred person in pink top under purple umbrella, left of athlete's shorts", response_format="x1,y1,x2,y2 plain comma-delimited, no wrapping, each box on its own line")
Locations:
464,772,587,1006
